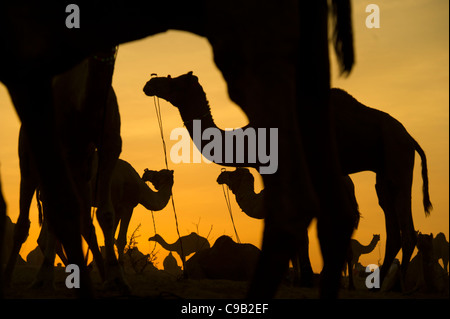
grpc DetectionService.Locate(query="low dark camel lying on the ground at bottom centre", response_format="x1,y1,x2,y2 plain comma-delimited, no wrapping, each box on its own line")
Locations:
186,235,260,281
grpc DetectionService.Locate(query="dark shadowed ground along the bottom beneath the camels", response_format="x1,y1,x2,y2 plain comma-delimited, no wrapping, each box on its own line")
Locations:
5,265,449,300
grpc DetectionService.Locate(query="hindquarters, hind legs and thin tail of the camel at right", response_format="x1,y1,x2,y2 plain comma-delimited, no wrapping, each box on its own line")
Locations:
331,89,432,280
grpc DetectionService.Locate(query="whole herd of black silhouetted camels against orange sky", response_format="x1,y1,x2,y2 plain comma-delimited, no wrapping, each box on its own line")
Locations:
0,0,448,298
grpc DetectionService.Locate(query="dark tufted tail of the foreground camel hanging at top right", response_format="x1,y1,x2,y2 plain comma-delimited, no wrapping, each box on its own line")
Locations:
331,0,355,76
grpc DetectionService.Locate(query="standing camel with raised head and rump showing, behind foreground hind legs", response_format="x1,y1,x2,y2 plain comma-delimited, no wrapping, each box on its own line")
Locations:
144,72,432,284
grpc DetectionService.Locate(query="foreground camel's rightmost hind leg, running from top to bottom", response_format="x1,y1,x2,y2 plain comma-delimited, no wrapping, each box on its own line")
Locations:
296,1,354,298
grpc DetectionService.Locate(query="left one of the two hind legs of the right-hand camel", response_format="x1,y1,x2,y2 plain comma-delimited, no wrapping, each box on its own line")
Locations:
375,180,401,283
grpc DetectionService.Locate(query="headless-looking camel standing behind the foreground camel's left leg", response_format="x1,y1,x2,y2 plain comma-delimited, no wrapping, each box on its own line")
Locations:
6,48,128,290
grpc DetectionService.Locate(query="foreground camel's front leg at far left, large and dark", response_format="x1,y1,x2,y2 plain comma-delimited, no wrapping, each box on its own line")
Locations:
7,79,91,296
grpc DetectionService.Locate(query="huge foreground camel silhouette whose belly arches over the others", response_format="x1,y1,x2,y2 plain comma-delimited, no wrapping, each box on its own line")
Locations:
0,0,354,298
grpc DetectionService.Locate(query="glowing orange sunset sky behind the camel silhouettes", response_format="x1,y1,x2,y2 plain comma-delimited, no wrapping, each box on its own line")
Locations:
0,0,449,272
